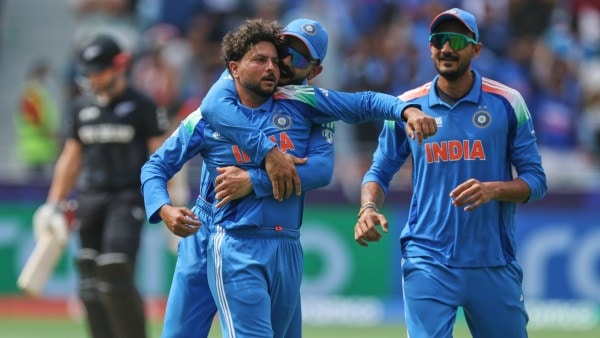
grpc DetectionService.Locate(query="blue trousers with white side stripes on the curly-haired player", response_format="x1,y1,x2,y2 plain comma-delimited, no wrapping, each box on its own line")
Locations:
208,226,303,338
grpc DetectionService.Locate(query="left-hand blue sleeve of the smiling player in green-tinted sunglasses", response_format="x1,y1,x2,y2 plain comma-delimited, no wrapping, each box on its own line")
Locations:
362,121,411,194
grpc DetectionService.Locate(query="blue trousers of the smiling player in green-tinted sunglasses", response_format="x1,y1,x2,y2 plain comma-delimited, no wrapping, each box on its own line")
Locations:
402,257,529,338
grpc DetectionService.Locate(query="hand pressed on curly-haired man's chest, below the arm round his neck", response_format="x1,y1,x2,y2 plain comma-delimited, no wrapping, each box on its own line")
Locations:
265,147,307,201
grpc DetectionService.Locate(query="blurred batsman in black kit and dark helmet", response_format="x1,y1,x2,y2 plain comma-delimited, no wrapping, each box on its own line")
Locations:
34,35,168,338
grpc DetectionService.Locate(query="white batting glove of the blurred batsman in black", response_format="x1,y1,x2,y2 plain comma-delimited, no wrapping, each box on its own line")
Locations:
33,202,69,245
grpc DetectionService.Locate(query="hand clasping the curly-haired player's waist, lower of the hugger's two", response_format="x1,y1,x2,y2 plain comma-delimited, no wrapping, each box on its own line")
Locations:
215,166,252,208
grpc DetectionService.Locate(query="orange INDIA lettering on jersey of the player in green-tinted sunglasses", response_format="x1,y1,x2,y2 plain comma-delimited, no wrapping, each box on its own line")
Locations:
425,140,485,163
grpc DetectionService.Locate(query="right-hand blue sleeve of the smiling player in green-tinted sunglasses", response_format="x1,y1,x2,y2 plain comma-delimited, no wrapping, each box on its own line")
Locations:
509,94,548,201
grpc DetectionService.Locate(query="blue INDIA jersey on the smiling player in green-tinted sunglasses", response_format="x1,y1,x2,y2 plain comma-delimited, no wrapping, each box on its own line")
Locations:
363,72,547,267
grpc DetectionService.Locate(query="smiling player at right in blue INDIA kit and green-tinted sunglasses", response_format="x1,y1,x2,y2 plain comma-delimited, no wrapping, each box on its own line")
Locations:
355,8,547,338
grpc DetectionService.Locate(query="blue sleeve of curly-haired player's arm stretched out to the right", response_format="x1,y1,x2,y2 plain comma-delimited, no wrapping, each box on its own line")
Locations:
274,85,421,124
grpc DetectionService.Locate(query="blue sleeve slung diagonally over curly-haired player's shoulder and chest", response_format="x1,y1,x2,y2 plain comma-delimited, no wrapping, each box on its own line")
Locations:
200,70,275,166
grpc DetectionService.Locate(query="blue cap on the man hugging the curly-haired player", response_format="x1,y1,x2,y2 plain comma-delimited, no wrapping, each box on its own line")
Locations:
281,19,329,63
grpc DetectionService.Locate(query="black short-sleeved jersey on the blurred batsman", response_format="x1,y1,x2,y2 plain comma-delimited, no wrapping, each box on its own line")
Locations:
67,88,167,191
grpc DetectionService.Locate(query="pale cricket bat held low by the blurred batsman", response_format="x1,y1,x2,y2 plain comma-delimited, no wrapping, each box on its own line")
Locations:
17,231,66,297
